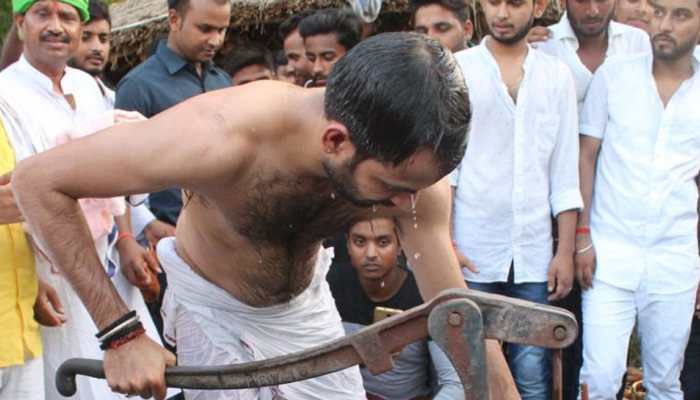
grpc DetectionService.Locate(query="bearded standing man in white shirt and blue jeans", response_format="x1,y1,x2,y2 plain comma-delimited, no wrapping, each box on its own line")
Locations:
450,0,583,400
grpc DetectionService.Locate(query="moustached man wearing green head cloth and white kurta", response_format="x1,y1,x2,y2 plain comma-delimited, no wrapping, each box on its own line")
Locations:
0,0,165,400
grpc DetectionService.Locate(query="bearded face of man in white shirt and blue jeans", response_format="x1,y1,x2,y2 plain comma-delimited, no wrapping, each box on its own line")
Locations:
481,0,544,45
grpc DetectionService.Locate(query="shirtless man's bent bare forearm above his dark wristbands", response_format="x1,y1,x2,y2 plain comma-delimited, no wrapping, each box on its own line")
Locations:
12,160,128,329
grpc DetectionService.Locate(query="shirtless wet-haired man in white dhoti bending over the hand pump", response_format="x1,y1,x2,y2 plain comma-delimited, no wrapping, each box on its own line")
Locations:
12,33,517,399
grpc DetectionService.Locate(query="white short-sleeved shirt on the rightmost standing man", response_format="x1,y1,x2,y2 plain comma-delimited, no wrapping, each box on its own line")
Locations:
580,53,700,293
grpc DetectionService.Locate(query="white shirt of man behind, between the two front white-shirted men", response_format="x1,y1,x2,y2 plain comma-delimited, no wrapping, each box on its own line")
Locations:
535,14,651,110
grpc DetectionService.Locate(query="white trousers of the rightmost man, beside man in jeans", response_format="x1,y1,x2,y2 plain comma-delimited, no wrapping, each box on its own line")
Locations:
580,279,695,400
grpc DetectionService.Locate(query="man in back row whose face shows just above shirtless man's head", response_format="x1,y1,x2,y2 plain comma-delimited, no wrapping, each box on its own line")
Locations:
411,0,474,53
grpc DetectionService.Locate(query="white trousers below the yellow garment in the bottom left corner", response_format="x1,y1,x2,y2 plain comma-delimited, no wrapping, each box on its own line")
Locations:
0,357,44,400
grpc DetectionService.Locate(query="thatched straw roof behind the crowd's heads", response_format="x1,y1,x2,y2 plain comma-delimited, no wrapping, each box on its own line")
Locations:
110,0,409,68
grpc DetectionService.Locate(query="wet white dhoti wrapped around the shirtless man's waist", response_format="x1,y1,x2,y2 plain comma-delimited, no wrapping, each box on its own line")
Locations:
158,238,366,400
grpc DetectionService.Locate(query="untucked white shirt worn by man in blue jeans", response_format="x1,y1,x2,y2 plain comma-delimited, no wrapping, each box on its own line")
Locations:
450,42,583,283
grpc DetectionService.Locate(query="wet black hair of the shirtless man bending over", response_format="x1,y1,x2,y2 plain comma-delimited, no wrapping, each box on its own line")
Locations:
325,32,471,175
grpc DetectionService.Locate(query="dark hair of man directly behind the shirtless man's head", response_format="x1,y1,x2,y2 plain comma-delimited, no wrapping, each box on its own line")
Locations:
299,8,362,51
